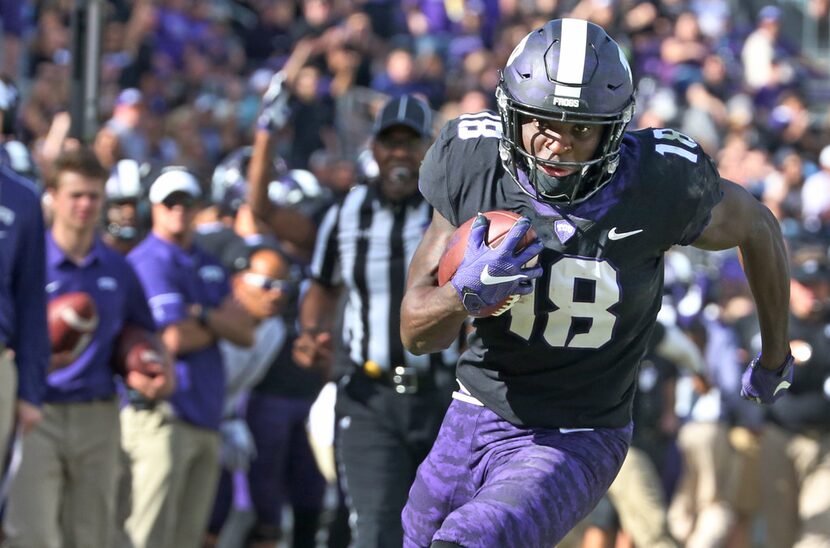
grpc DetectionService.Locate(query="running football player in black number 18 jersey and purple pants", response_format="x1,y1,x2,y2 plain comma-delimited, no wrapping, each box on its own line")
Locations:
401,19,792,547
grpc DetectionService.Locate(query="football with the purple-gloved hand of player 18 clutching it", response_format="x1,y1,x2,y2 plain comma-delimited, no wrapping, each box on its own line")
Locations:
438,211,544,318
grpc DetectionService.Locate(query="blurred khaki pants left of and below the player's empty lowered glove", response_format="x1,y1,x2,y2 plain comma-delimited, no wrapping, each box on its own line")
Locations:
668,422,734,548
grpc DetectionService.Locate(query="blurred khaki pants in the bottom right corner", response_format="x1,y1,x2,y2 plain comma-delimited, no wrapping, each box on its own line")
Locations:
761,425,830,548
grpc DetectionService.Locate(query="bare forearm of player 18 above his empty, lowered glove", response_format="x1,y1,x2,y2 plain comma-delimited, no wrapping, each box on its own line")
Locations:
740,202,790,369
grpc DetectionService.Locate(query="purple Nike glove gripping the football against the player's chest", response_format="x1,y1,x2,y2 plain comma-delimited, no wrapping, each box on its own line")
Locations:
450,215,544,314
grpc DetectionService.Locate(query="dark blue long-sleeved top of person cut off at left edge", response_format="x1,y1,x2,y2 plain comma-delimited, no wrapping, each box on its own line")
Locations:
0,169,49,405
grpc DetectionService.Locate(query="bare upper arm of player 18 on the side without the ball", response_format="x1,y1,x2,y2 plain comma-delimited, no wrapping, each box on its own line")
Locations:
692,179,761,251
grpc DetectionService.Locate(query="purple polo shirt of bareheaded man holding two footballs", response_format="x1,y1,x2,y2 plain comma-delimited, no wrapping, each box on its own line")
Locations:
44,231,155,403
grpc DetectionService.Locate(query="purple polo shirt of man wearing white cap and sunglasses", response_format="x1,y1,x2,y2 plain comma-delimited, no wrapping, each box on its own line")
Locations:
127,234,230,430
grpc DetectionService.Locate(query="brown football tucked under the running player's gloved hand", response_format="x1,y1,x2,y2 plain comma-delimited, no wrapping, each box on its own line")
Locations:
438,211,536,318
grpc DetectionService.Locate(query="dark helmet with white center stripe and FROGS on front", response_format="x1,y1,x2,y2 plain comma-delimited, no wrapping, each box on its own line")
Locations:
496,19,634,203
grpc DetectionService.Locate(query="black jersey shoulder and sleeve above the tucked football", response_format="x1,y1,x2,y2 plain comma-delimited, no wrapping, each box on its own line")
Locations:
419,111,502,226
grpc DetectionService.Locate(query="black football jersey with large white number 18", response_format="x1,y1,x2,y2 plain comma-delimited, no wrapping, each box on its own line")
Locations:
420,112,721,428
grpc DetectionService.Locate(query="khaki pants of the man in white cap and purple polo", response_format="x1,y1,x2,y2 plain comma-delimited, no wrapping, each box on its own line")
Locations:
121,403,220,548
